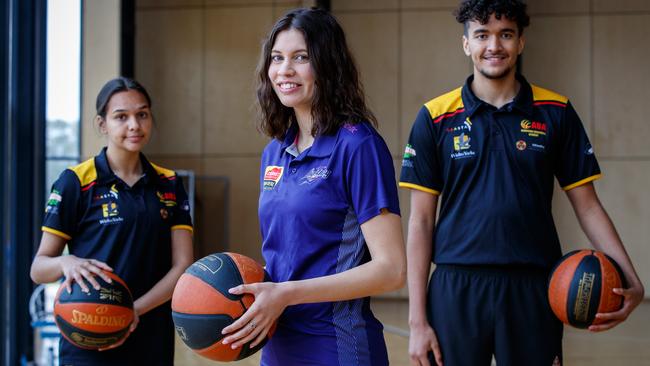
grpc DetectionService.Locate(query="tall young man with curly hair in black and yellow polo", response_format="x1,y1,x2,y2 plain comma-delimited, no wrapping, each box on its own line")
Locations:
400,0,644,366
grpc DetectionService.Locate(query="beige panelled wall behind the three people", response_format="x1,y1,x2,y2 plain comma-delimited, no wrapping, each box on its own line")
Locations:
120,0,650,294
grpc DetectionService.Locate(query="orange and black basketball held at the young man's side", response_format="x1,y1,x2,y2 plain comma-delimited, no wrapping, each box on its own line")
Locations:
548,249,625,328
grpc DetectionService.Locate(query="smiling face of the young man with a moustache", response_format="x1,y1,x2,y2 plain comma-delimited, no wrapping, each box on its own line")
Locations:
463,14,525,80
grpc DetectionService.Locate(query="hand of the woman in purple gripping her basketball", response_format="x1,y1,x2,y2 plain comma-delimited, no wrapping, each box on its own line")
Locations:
222,282,288,349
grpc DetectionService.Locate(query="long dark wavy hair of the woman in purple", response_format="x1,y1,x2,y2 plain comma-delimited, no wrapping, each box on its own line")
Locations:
256,9,377,139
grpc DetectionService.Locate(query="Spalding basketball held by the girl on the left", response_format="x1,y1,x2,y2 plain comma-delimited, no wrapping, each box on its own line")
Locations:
54,271,134,350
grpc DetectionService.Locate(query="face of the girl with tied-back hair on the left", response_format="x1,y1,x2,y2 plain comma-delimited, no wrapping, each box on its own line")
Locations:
99,89,153,153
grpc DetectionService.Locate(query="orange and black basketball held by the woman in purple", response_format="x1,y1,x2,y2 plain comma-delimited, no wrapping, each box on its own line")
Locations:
172,253,275,361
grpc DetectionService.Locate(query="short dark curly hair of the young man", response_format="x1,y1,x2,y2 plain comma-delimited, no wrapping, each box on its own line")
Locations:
454,0,530,35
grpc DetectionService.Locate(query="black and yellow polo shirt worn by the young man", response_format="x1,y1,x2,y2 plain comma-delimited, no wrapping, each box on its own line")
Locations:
399,75,600,268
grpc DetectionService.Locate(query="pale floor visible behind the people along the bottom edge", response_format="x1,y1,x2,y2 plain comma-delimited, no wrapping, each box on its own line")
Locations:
176,300,650,366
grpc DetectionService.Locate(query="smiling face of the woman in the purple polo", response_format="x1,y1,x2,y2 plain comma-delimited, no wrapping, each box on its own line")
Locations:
268,28,315,120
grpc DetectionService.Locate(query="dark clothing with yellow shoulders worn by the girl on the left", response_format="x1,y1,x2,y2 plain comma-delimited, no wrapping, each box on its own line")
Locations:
42,148,192,365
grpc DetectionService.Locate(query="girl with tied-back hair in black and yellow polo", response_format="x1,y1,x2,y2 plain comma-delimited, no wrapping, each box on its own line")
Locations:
31,78,192,366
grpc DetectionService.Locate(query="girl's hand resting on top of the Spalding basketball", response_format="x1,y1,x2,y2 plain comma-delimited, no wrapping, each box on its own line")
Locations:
60,255,113,293
